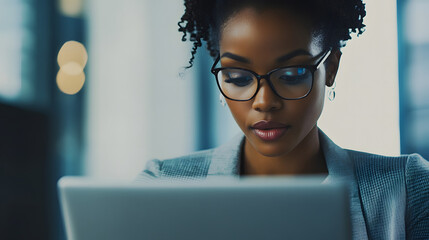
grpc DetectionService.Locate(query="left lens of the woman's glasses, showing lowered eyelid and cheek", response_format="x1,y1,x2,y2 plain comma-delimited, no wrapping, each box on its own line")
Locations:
217,68,258,100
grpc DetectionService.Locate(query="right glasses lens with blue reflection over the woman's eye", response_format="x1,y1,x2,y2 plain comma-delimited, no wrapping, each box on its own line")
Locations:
270,67,313,99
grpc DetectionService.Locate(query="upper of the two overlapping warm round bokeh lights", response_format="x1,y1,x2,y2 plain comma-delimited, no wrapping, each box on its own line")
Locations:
57,41,88,69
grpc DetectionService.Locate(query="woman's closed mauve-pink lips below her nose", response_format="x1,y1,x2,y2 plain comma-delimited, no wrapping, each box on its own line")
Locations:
251,120,290,141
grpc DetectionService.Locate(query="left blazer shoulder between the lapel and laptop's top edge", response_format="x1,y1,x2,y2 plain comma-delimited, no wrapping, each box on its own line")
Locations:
136,149,214,181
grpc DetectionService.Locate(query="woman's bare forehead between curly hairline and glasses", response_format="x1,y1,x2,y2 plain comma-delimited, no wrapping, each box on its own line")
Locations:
219,8,319,56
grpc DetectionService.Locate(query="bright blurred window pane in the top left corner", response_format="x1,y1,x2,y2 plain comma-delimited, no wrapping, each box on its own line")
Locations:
0,0,35,104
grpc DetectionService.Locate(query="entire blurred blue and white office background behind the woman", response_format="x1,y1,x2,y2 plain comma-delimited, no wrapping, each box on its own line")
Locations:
0,0,429,239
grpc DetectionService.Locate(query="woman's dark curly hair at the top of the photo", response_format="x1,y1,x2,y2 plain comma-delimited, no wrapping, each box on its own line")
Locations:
178,0,366,68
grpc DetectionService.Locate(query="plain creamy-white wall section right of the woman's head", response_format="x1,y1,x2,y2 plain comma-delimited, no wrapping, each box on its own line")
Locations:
319,0,400,155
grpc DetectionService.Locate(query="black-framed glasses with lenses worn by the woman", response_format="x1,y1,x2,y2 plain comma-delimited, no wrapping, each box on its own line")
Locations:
211,49,331,101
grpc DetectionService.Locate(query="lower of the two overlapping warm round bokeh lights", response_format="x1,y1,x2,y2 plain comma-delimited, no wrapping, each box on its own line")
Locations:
57,69,85,95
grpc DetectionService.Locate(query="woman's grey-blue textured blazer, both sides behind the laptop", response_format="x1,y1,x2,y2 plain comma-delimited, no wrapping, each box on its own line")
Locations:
136,129,429,239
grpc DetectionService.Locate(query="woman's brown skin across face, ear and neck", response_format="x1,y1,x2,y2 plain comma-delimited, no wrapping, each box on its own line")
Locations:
219,7,341,175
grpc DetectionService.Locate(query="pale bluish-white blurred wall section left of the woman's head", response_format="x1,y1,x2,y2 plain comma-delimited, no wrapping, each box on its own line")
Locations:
86,0,194,179
